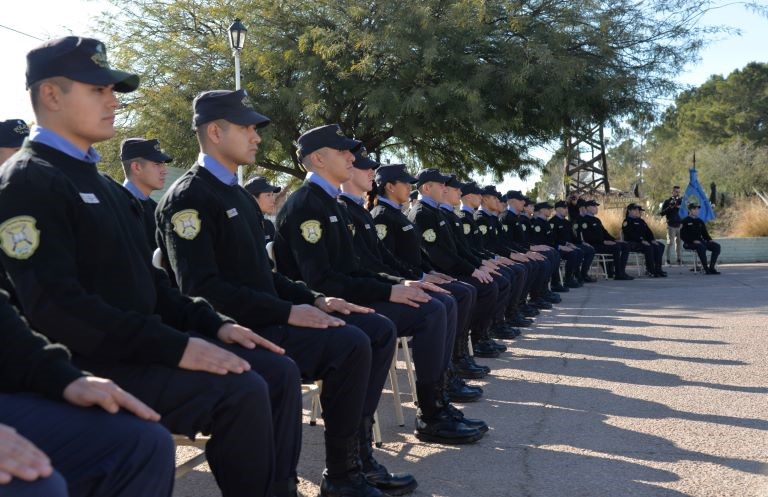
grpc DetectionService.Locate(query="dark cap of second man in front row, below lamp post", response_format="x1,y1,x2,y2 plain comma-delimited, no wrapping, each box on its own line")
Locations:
192,89,270,128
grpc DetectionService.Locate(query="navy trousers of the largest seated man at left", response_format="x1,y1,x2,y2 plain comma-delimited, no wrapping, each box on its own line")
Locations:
75,333,301,497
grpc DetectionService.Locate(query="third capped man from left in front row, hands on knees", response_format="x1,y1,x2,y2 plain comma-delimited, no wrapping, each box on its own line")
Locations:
275,124,488,443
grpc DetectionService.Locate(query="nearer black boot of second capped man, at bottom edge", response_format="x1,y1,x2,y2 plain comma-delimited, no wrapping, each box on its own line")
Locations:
320,431,383,497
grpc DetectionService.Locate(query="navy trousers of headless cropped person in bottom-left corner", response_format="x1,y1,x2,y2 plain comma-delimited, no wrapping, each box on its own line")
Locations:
0,394,175,497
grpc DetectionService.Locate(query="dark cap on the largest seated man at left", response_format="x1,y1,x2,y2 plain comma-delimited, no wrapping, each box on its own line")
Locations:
27,36,139,93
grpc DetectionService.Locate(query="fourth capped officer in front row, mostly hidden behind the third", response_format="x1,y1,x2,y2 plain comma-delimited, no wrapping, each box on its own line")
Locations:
339,147,482,402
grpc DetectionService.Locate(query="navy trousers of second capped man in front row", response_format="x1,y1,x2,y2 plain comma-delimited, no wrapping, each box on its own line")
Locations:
258,314,395,438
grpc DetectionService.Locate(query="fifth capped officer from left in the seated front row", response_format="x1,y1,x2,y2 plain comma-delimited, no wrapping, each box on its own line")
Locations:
371,164,490,378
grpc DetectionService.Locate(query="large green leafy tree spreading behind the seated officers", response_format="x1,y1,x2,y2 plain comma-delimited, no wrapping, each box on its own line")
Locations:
94,0,709,178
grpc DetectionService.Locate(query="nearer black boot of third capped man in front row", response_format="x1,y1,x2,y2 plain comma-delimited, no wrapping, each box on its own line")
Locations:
414,380,483,445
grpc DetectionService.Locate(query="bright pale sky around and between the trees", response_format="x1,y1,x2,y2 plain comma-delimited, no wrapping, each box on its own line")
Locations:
0,0,768,192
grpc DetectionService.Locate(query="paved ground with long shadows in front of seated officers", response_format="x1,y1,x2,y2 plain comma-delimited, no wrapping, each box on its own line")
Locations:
174,264,768,497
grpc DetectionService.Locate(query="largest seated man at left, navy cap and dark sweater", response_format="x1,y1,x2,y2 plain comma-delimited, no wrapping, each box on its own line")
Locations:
0,36,301,497
